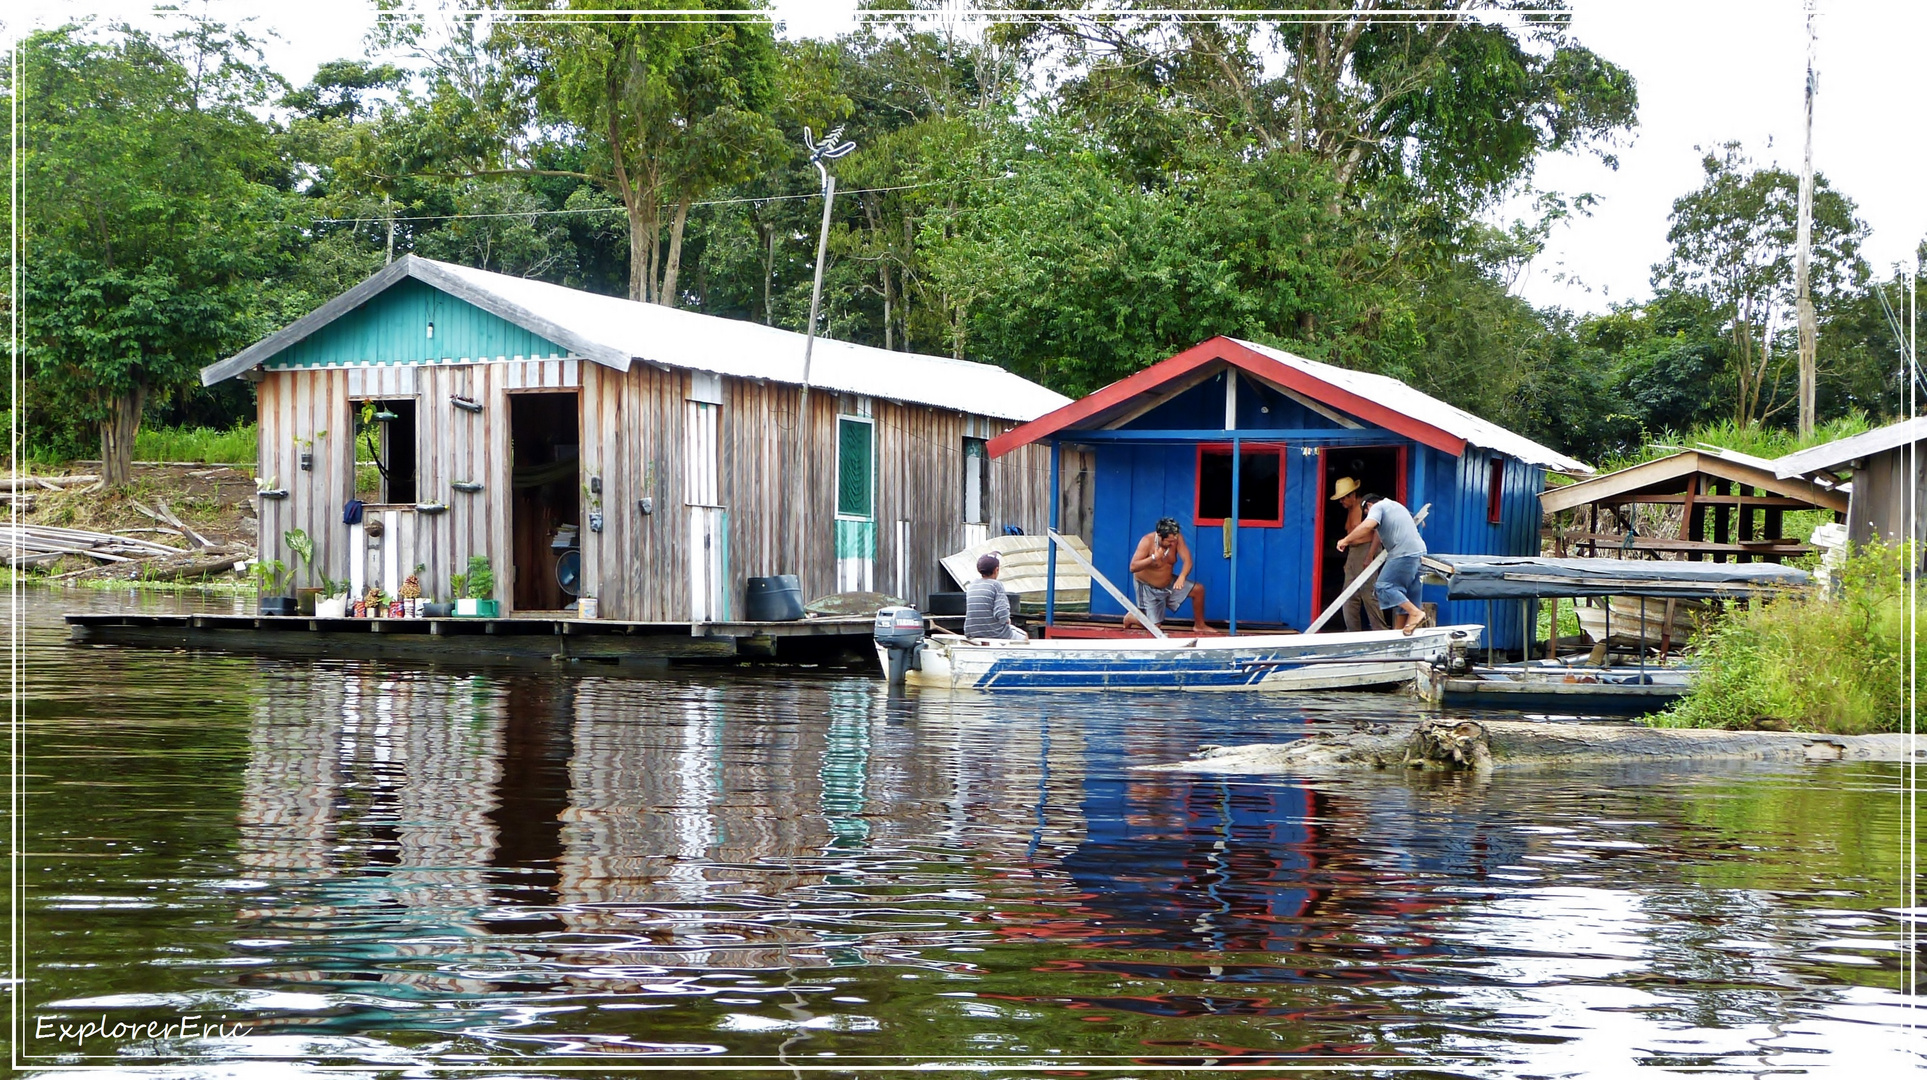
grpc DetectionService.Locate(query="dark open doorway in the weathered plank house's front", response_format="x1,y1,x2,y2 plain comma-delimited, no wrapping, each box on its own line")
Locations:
509,390,582,611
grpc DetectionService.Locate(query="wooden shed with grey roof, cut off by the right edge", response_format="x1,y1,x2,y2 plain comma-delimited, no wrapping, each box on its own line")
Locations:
1773,417,1927,544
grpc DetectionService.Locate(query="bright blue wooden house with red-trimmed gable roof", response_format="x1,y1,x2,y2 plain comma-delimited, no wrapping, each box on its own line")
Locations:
990,338,1592,648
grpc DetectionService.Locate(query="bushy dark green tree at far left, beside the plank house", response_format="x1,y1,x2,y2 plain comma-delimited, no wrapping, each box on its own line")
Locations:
6,21,299,484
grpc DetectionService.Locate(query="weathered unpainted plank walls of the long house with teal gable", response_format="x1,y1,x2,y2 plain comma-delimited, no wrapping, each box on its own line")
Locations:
260,363,1050,623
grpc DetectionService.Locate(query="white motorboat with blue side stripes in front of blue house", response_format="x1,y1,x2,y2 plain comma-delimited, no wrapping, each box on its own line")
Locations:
877,625,1482,690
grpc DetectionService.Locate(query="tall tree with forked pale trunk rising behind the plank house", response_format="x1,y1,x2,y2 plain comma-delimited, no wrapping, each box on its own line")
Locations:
402,0,782,305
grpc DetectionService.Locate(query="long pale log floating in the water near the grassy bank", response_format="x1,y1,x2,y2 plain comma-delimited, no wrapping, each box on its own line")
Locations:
1135,719,1927,775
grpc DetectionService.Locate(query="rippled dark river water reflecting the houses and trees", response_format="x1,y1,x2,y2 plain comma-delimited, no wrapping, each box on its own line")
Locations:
12,590,1927,1076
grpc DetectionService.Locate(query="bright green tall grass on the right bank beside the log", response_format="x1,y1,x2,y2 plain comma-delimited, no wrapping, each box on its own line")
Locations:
1655,544,1927,735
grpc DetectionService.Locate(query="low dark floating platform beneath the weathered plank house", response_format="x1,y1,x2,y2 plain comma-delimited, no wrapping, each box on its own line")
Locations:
66,613,901,665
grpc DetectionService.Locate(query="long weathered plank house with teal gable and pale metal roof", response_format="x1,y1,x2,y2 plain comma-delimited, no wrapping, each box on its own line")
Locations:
200,257,1068,623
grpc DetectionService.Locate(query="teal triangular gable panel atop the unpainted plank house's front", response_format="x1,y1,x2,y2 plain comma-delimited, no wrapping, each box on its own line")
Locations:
266,278,568,368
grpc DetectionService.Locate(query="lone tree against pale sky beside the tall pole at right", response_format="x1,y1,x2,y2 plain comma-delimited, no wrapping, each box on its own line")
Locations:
1653,143,1867,428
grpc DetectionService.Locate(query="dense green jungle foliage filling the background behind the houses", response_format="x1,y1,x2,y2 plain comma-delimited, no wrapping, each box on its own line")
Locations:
0,0,1906,471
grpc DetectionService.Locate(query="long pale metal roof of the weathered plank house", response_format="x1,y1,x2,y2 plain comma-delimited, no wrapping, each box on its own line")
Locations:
200,255,1069,420
